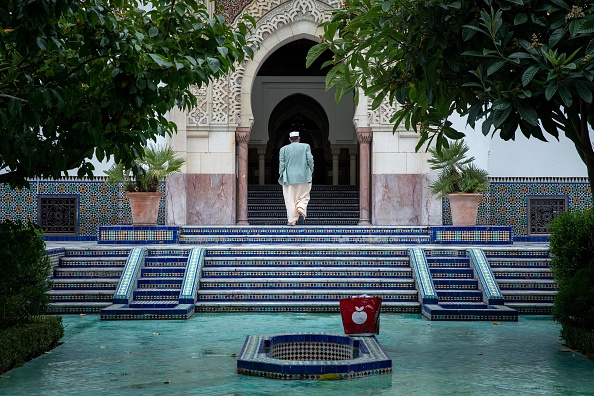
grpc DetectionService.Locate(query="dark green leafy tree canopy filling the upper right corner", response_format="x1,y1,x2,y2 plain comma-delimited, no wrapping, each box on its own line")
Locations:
307,0,594,197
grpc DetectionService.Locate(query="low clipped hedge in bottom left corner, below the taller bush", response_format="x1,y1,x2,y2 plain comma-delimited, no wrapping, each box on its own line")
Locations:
0,316,64,374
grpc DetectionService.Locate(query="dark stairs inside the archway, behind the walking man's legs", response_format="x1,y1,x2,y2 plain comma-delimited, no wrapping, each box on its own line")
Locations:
248,184,359,225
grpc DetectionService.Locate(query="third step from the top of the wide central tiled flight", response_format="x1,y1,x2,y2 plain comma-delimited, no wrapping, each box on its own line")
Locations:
200,277,415,292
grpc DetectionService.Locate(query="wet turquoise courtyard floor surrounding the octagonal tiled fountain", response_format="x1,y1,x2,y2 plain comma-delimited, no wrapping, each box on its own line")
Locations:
0,314,594,396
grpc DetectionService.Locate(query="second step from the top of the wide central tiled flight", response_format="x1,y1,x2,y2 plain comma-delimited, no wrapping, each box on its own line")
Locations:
202,266,412,279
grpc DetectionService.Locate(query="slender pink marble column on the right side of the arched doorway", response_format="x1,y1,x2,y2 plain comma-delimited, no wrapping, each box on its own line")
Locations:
357,127,373,225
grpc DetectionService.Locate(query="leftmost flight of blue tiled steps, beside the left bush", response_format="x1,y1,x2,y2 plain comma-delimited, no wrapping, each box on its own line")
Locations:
48,248,128,314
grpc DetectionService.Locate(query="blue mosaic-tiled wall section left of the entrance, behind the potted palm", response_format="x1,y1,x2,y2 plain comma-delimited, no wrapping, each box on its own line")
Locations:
0,177,165,237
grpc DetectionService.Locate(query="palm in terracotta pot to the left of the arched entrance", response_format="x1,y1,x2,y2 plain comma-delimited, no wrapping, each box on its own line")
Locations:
105,144,185,225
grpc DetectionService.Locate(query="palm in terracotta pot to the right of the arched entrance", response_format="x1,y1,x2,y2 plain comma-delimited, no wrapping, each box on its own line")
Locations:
429,140,489,226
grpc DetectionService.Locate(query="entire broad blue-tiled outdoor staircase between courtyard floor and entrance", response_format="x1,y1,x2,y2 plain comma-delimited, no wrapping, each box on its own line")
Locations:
45,226,556,321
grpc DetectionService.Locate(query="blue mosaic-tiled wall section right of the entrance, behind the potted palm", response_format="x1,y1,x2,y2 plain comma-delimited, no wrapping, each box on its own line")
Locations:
442,177,592,236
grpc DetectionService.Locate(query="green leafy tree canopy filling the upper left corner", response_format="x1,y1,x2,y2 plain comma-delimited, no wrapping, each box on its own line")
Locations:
0,0,254,186
